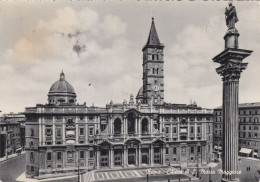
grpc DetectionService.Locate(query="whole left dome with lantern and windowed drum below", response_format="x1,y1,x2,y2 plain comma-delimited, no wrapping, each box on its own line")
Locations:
48,72,77,104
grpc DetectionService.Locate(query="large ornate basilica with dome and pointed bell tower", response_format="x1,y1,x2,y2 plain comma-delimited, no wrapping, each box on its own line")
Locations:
25,20,213,179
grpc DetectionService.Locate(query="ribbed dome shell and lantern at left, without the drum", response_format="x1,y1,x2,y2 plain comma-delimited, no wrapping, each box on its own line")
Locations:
49,71,76,94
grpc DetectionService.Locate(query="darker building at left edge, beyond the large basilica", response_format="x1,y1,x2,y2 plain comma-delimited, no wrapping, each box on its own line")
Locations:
0,113,25,157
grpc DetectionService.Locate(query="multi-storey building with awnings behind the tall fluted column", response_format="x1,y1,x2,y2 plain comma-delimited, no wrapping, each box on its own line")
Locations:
213,102,260,157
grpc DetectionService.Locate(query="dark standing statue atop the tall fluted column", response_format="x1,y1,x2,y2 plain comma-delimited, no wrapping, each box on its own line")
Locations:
225,2,238,29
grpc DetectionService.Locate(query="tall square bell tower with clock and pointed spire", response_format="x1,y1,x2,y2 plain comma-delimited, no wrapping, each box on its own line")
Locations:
142,18,164,105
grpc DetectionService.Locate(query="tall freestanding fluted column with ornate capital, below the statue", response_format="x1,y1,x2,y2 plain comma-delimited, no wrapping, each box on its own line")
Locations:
213,14,253,182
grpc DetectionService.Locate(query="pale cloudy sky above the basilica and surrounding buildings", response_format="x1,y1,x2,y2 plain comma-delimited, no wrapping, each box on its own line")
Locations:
0,0,260,114
